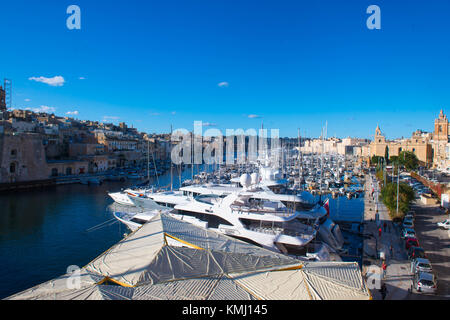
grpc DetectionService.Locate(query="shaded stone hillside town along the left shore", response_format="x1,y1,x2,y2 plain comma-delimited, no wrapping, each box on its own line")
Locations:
0,82,170,184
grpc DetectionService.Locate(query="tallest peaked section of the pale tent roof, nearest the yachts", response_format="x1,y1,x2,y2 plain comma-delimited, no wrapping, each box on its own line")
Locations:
86,214,301,286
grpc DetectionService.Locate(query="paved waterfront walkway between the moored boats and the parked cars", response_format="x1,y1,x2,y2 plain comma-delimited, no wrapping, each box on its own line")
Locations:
363,174,412,300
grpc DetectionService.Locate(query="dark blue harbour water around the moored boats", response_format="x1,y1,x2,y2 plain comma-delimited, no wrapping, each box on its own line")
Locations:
0,168,364,299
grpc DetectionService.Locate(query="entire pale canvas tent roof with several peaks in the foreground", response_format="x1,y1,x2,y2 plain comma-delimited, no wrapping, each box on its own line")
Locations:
9,214,370,300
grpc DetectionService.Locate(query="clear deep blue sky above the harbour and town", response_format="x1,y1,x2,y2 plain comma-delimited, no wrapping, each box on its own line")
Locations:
0,0,450,138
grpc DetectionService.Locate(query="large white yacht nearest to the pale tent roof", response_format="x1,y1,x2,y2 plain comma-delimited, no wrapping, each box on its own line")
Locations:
114,193,317,253
